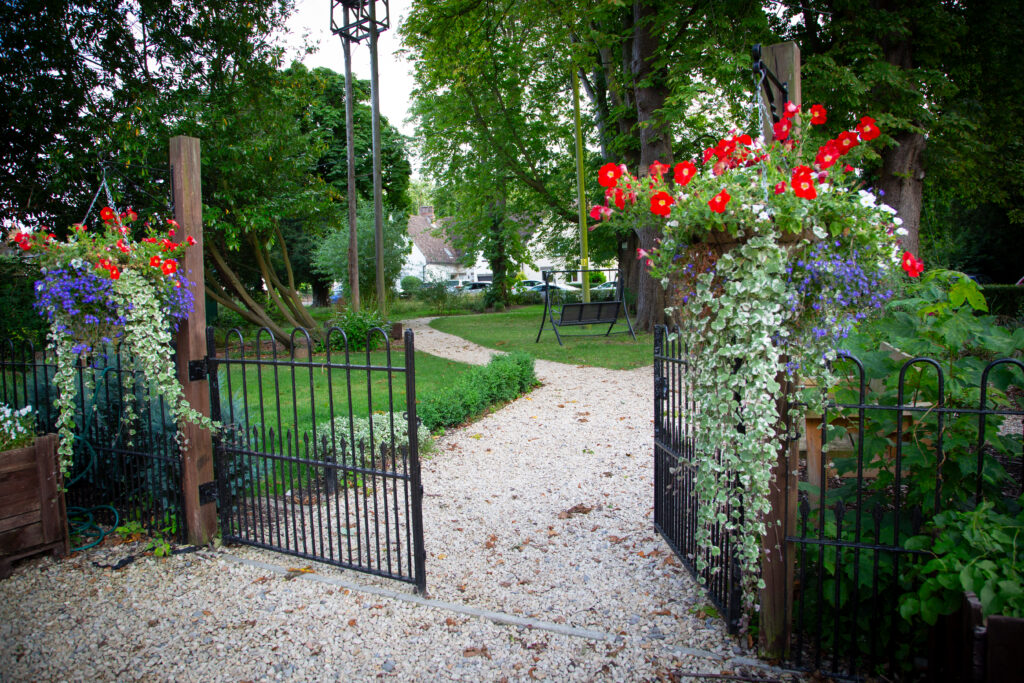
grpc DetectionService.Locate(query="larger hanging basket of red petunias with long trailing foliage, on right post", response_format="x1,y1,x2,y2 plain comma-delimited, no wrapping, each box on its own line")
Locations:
591,102,923,615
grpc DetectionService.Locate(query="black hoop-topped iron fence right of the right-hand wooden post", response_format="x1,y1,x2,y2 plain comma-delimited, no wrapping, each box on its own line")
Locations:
786,356,1024,678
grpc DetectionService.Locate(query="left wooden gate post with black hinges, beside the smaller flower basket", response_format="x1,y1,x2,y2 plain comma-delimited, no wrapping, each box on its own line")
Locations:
170,135,217,546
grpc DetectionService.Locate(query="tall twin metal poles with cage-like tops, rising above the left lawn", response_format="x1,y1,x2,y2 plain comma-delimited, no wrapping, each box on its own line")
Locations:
331,0,390,312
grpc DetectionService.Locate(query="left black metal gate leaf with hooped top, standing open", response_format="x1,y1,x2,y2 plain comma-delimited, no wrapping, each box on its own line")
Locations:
207,328,426,592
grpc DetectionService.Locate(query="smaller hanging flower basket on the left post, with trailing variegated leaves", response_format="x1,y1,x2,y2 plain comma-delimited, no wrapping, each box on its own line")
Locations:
9,207,212,475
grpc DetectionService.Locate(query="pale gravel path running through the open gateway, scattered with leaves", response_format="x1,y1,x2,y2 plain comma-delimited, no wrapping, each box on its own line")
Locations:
0,321,788,681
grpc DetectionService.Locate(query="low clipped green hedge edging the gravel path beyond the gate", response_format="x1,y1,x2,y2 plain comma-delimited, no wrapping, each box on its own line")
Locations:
417,353,537,431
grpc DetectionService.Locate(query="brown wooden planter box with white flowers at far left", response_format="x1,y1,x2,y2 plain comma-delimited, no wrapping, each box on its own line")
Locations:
0,434,70,579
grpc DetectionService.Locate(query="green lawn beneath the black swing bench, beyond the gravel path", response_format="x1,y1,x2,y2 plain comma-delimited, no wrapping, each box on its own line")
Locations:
430,306,654,370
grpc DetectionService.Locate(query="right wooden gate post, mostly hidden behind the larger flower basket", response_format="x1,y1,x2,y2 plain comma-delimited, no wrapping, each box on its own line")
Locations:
759,41,803,658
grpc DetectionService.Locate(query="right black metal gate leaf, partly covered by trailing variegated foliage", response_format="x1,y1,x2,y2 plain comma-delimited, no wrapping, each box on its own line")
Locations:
654,327,740,633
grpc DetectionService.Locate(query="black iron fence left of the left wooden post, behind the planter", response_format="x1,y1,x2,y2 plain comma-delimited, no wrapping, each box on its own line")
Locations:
0,340,185,541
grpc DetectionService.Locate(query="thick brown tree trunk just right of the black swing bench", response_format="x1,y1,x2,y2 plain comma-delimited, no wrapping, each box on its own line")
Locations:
630,0,673,332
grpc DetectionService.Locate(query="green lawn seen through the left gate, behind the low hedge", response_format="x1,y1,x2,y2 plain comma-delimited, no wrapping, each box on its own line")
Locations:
218,350,471,440
